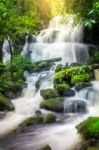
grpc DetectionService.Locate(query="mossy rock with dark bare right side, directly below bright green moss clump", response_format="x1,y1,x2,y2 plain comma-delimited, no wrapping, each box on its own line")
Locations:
56,84,75,97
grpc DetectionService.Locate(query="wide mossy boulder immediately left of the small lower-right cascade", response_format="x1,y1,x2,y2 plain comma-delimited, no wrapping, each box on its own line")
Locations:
40,97,64,112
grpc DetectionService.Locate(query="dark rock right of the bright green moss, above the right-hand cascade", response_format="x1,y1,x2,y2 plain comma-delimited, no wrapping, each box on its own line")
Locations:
75,82,92,91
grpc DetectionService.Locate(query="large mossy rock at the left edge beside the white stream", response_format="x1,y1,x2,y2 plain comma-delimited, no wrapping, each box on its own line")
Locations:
0,94,14,111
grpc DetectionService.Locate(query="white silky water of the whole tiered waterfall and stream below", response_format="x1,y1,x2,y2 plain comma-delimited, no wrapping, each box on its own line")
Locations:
0,16,99,150
